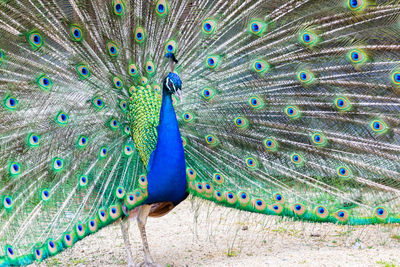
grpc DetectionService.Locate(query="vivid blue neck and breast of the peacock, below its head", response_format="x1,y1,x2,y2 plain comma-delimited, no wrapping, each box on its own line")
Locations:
146,91,187,204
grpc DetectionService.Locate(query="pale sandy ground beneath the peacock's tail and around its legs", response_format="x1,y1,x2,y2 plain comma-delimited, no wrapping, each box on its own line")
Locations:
36,200,400,267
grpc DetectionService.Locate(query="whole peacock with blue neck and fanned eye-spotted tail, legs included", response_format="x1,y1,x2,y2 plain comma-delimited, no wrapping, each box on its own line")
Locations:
0,0,400,266
